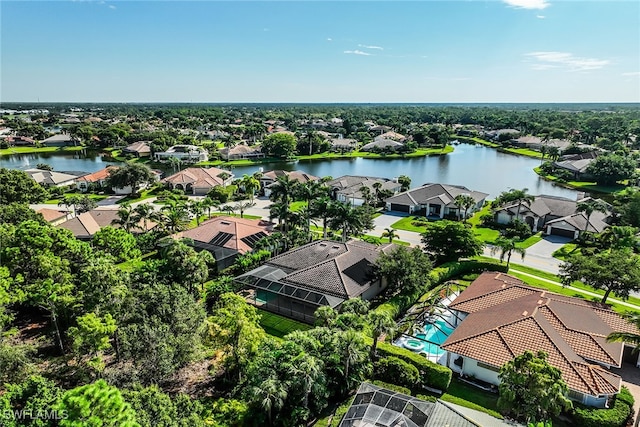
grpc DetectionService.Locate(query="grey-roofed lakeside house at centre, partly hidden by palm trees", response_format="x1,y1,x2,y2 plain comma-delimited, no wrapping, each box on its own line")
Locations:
326,175,402,206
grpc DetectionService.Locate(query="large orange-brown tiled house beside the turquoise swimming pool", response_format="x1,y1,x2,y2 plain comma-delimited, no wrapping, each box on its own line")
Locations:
440,272,638,407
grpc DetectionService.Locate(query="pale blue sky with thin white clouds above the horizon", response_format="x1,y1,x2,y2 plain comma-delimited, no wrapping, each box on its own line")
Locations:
0,0,640,102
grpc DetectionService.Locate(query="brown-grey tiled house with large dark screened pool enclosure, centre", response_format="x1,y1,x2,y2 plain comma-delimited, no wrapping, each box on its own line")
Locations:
234,240,395,323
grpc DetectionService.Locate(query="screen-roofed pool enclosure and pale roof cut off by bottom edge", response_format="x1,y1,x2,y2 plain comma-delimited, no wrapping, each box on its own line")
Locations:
339,382,514,427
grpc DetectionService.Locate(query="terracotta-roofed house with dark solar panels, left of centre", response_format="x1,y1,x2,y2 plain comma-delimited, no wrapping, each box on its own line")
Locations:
172,216,271,270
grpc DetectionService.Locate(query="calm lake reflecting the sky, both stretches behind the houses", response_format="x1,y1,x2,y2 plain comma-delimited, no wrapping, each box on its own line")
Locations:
0,144,576,198
